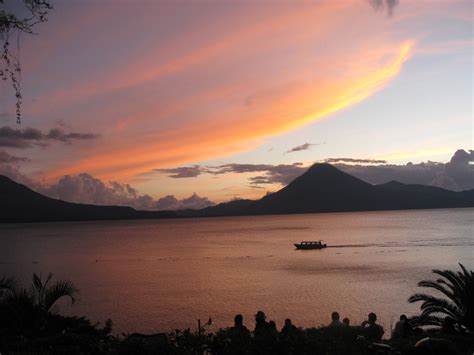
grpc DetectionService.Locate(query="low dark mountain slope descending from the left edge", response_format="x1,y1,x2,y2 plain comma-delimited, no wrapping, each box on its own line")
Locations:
0,175,175,222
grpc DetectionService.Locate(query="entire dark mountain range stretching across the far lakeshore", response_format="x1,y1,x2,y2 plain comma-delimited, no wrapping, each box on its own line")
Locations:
0,164,474,222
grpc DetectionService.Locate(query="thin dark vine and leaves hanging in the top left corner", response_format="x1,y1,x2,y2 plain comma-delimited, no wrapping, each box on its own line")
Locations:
0,0,53,124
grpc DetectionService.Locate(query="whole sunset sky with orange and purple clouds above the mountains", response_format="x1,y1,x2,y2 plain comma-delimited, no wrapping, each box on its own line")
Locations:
0,0,473,208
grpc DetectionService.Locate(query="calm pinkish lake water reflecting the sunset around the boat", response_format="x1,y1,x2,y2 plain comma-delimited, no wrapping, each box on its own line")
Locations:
0,209,474,334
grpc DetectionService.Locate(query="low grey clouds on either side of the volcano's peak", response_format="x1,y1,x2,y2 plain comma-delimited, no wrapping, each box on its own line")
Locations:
156,149,474,191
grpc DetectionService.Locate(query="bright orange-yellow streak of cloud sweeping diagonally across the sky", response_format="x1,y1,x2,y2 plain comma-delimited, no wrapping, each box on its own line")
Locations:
47,41,413,180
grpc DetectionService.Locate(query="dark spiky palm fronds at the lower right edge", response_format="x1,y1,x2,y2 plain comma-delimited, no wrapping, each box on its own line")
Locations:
408,263,474,331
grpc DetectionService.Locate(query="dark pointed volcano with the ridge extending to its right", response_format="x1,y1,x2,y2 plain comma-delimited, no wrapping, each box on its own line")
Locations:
195,164,474,216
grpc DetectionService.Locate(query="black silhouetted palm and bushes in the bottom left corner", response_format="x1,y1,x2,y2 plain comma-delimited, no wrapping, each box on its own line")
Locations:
0,274,115,354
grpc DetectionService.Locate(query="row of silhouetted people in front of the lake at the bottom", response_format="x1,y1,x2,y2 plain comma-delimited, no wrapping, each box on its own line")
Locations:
221,311,466,354
